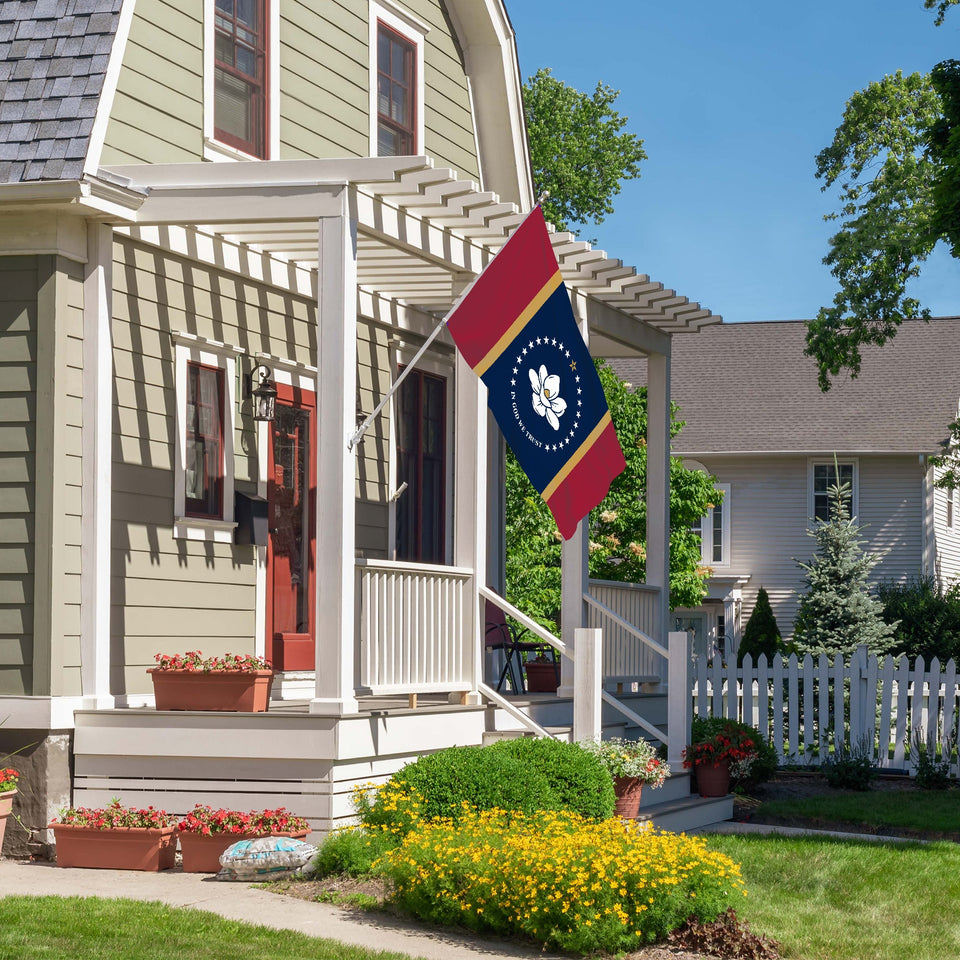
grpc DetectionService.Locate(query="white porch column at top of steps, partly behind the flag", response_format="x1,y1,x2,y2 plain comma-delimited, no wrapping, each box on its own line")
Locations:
453,350,487,704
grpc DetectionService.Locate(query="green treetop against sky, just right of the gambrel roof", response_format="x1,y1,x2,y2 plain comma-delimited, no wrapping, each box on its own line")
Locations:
523,68,647,230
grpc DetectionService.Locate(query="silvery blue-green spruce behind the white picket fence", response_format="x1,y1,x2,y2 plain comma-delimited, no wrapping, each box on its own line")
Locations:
793,483,896,657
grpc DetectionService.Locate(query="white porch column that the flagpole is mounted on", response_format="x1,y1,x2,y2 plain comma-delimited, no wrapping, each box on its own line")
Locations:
310,186,358,716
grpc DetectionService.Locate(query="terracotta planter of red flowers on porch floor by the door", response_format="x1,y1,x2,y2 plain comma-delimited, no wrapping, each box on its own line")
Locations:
147,650,273,713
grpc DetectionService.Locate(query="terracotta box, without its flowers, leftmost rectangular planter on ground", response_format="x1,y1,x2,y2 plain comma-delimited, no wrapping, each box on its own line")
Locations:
50,823,177,870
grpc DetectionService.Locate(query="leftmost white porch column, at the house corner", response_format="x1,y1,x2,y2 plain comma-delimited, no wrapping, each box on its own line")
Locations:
80,223,113,707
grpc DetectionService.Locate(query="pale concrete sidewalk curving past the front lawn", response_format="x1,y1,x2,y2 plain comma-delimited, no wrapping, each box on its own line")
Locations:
0,860,561,960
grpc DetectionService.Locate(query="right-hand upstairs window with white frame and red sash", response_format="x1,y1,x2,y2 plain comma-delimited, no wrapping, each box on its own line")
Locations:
370,0,429,157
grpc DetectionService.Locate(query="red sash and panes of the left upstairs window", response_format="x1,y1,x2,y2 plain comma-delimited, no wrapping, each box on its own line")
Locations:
213,0,267,159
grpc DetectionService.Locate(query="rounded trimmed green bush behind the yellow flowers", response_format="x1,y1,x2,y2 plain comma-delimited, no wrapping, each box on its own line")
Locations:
370,737,614,833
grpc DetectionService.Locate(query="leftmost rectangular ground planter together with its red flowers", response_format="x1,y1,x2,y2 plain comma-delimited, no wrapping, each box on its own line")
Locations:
50,799,177,870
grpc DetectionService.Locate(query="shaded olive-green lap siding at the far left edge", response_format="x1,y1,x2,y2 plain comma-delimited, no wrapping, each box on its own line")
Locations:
0,257,37,694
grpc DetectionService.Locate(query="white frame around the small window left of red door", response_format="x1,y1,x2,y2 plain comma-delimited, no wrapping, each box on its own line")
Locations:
173,333,243,543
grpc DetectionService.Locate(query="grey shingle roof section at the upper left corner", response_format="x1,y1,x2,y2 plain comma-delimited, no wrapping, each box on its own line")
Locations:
0,0,122,183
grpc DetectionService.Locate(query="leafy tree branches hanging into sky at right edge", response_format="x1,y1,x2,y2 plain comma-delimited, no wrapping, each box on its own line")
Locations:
806,7,960,390
